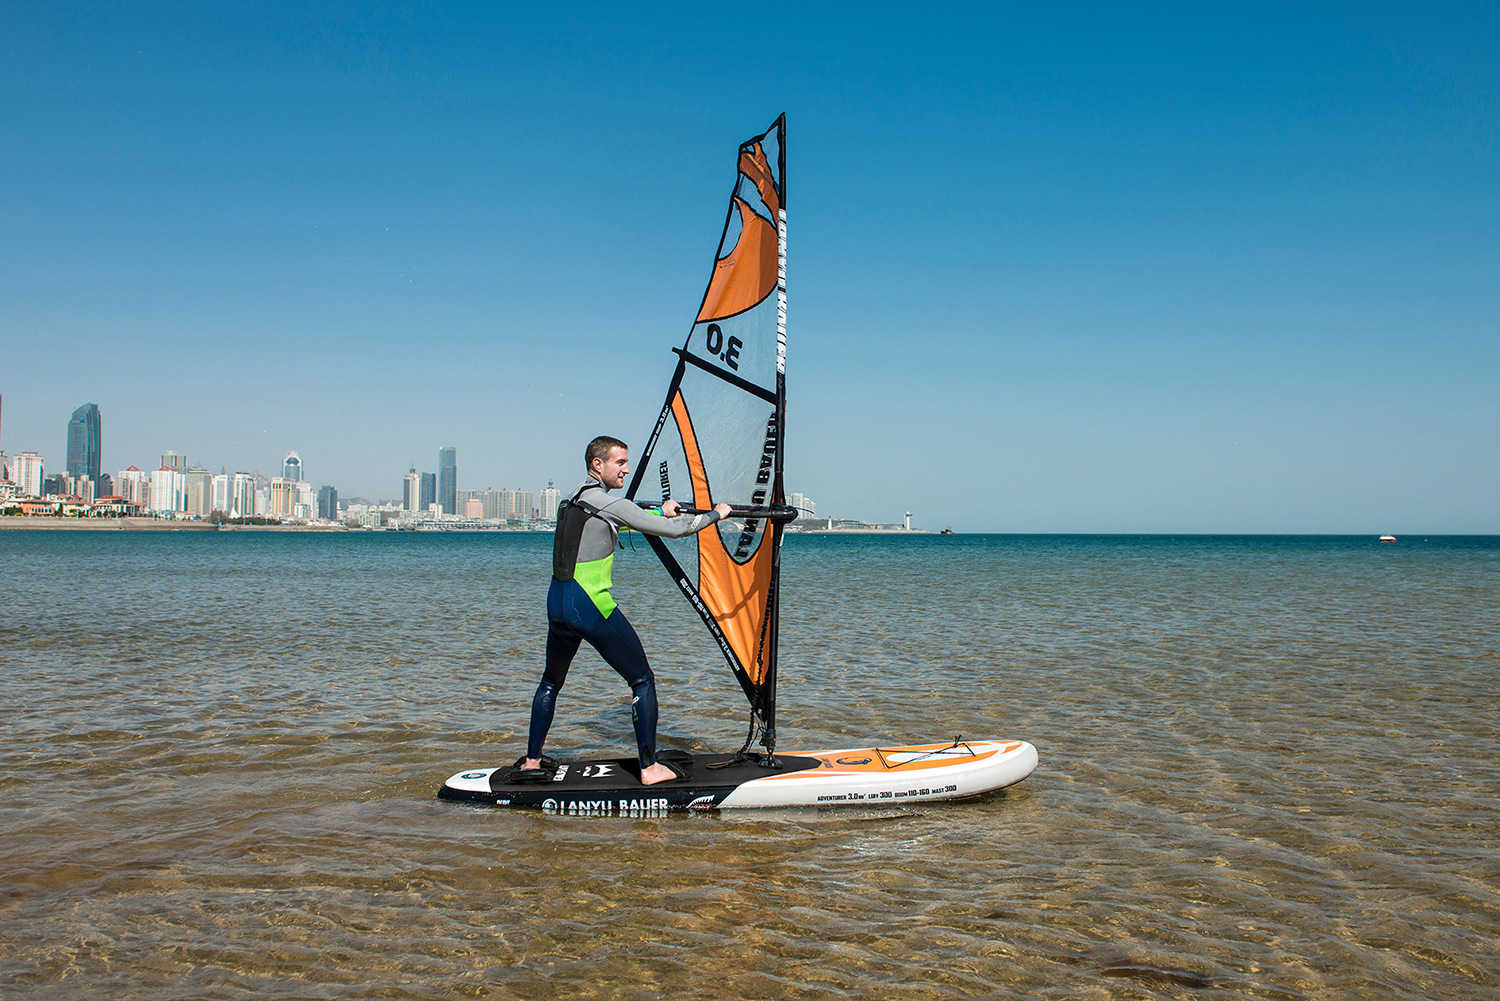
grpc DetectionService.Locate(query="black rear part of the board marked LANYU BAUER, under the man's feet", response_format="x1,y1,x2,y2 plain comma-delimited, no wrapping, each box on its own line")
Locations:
438,752,822,815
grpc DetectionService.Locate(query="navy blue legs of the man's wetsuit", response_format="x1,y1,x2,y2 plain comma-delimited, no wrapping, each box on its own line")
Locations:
527,579,657,768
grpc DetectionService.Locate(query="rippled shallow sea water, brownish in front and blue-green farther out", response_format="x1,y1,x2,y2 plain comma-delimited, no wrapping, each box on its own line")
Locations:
0,531,1500,999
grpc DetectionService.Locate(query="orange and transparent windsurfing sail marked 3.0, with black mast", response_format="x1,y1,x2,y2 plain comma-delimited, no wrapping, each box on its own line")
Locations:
629,116,795,750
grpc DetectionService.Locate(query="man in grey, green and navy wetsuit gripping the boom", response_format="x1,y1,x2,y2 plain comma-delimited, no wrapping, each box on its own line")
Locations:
521,437,729,785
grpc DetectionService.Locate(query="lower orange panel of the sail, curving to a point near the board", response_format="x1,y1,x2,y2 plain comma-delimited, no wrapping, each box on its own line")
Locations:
672,390,773,684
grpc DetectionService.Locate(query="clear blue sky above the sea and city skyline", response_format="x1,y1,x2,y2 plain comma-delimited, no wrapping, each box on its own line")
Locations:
0,3,1500,534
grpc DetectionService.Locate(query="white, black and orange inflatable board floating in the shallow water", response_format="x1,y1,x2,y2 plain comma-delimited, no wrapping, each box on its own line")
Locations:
438,740,1037,816
